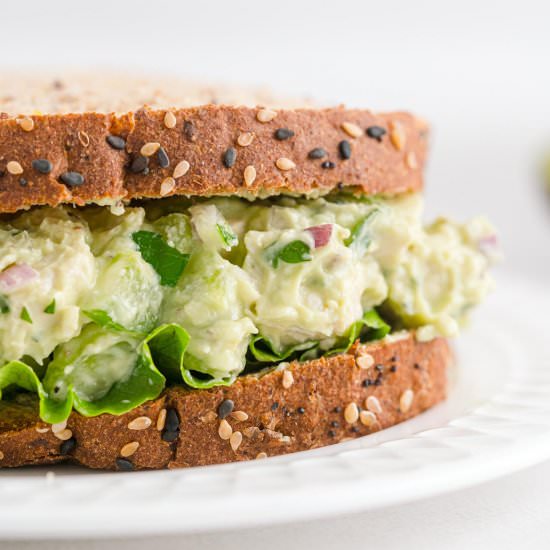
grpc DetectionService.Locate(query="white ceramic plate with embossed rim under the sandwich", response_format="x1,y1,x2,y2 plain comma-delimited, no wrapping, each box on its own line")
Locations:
0,278,550,538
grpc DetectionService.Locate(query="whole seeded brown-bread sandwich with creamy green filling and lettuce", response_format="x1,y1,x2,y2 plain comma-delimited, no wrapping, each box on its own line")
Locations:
0,78,496,471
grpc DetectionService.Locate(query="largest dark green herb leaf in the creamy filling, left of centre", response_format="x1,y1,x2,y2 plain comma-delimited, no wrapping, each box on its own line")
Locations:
132,231,190,287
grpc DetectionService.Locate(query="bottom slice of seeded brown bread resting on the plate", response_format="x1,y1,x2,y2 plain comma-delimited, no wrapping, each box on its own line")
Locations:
0,333,452,470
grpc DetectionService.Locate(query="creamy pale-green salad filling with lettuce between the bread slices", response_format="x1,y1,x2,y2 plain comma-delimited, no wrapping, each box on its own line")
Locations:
0,193,496,423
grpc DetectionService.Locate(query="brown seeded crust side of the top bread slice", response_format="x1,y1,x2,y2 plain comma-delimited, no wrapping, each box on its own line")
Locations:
0,105,427,213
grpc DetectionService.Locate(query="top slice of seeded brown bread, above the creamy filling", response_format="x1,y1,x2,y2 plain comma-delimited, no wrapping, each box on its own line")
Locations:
0,75,427,213
